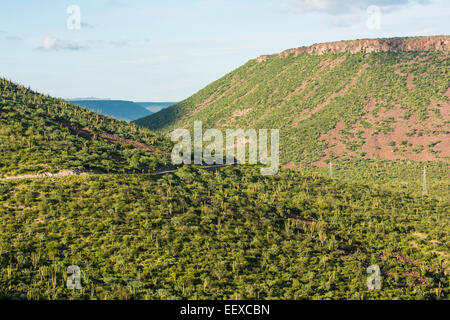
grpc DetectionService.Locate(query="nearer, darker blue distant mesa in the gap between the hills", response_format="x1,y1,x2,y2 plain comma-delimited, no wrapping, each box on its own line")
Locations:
69,100,153,121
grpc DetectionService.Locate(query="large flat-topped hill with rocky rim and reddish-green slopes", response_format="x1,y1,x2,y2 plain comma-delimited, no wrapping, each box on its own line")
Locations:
136,36,450,167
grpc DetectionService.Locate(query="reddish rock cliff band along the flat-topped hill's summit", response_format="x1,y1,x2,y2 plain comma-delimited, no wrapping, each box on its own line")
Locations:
279,36,450,58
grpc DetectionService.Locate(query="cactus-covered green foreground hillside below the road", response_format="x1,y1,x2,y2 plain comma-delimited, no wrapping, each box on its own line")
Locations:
0,167,450,299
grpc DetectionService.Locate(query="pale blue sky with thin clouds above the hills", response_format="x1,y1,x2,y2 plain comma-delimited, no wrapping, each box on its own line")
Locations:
0,0,450,102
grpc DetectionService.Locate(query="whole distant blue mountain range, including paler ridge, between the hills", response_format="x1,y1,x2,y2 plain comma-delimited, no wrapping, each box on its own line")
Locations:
67,97,175,121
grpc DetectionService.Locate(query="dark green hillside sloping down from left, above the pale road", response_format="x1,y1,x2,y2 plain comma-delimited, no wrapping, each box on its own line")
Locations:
0,79,171,177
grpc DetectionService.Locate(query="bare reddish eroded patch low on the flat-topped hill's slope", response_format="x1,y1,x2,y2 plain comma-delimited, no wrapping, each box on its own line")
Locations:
313,88,450,167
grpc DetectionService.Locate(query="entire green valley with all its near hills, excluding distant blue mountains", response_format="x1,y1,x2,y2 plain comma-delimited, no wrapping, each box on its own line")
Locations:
0,36,450,300
